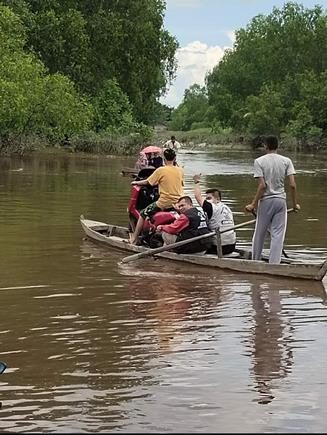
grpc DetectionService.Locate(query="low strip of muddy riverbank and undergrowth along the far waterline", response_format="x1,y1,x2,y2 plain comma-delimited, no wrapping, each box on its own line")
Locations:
0,128,327,156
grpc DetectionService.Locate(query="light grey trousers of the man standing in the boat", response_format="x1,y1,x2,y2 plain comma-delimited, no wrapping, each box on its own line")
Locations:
252,198,287,264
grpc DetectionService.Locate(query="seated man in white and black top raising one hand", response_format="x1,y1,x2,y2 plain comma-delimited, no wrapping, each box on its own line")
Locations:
193,174,236,255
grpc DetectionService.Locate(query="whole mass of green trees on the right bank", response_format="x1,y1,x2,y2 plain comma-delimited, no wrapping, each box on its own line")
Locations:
169,2,327,148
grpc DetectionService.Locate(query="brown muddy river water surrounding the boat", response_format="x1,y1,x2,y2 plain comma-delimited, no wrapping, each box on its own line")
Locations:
0,150,327,433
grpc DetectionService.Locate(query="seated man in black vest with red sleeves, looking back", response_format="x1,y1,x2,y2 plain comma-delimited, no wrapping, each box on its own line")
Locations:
157,196,212,254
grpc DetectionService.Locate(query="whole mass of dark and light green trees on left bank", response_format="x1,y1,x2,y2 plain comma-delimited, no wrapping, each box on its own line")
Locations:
0,0,178,152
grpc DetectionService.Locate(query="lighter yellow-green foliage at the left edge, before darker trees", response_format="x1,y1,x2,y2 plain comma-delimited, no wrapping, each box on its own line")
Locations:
0,6,92,145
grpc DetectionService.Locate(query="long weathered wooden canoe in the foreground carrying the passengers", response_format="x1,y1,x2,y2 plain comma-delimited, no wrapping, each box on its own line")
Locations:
80,216,327,281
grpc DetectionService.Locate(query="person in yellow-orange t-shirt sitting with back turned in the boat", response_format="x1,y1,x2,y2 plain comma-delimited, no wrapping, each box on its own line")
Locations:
130,148,184,244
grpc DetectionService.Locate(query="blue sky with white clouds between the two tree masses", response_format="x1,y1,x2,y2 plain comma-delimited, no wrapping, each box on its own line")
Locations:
160,0,327,107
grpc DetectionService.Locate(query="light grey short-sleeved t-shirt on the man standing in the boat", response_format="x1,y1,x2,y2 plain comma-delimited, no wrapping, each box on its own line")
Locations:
254,153,296,199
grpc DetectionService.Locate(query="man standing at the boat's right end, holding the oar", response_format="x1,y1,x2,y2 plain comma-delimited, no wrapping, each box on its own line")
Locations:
245,136,300,264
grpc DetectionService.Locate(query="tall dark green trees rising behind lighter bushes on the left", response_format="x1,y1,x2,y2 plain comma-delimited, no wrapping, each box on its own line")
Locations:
4,0,178,122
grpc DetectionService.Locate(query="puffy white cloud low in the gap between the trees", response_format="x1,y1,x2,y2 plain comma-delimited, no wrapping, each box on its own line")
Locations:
160,40,232,107
